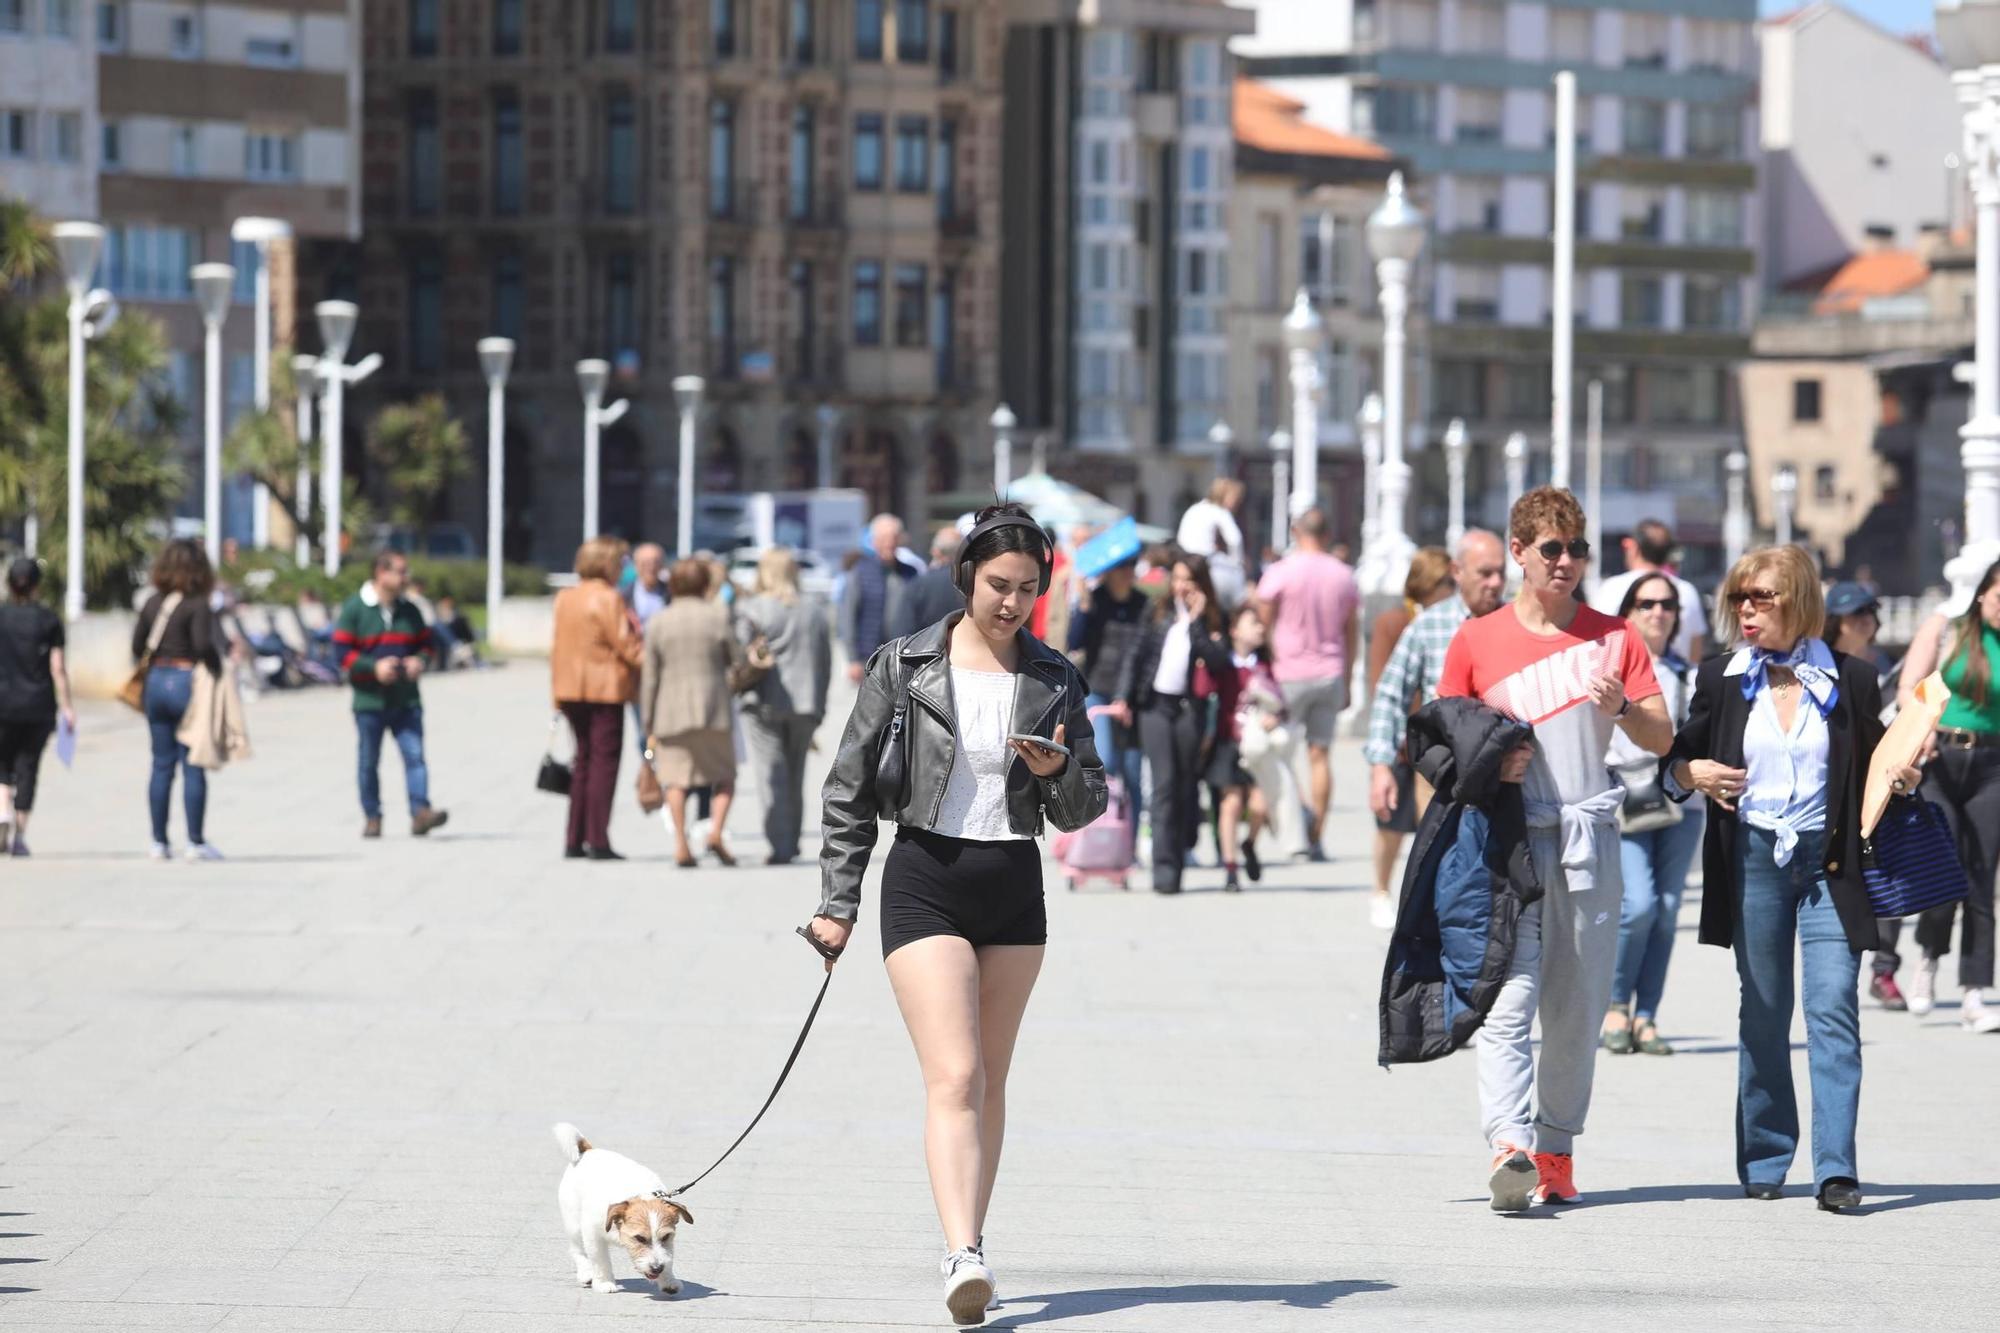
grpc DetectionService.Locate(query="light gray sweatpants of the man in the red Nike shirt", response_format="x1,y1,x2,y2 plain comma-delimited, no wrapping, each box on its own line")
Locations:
1476,825,1624,1153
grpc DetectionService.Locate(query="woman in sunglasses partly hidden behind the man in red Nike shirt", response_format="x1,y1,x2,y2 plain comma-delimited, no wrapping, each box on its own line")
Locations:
1604,574,1706,1055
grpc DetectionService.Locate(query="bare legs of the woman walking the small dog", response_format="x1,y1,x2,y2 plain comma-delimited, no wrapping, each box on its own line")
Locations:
888,935,1044,1249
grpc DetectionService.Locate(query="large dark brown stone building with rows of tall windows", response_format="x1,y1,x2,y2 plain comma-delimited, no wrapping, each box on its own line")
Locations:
352,0,1002,564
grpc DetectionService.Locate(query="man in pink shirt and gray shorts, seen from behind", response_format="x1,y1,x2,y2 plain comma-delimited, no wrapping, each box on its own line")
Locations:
1256,508,1362,861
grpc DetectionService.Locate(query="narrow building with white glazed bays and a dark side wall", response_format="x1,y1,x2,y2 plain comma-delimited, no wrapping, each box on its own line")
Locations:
1000,0,1254,522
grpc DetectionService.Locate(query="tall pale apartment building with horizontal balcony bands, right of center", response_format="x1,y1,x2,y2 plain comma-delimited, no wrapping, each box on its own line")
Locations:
1238,0,1760,572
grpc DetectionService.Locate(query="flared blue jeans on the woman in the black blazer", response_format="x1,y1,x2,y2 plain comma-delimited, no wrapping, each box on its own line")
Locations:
1708,827,1862,1189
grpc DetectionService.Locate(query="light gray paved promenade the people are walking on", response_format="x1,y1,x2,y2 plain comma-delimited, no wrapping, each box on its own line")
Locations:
0,662,2000,1333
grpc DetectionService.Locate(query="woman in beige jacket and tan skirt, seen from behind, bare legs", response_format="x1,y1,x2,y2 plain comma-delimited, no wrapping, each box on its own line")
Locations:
638,556,744,869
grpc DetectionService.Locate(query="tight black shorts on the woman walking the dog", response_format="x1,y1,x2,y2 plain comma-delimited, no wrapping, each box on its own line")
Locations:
882,829,1048,959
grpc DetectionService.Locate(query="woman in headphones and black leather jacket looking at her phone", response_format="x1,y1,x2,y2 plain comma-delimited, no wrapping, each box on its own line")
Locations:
810,504,1106,1325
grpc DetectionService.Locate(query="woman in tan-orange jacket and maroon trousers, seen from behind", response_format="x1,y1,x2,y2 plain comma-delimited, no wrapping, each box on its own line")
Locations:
548,536,644,861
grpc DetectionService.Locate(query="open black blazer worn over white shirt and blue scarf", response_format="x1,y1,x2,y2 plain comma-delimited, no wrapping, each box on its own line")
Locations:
1660,652,1882,951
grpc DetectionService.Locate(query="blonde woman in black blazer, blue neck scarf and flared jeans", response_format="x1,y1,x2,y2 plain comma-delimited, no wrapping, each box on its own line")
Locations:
1662,546,1920,1211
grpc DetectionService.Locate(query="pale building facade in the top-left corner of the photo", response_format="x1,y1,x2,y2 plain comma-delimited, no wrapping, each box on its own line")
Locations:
0,0,98,218
